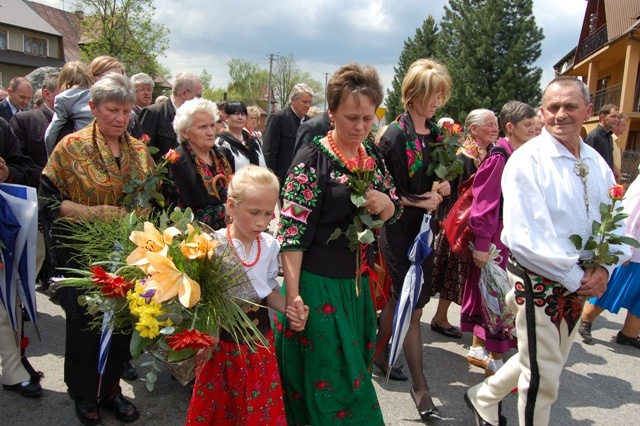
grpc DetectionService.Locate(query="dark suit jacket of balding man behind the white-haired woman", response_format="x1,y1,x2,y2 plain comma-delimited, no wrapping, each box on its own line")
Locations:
139,100,178,163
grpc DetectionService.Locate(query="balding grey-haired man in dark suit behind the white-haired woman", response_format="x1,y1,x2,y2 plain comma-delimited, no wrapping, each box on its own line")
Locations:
140,72,202,163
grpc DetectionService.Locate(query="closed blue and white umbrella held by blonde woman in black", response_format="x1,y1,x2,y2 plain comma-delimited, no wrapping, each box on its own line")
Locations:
387,213,433,381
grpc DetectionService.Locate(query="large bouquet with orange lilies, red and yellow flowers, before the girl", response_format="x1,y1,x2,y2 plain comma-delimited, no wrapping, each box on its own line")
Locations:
54,209,266,390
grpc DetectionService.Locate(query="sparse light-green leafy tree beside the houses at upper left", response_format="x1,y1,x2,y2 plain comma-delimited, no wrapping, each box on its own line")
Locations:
75,0,169,75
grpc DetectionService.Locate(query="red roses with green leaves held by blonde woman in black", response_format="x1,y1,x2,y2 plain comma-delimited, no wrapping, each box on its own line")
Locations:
427,121,463,180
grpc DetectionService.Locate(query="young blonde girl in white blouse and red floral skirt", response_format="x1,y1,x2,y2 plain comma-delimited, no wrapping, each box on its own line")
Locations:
187,165,309,425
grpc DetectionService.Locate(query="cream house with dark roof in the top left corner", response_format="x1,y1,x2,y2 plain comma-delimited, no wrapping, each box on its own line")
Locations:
0,0,65,86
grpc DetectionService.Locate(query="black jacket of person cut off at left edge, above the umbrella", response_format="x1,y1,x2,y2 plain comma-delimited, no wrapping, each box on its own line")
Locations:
0,118,40,187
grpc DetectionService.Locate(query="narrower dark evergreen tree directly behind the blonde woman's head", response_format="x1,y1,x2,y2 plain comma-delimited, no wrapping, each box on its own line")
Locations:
385,15,438,123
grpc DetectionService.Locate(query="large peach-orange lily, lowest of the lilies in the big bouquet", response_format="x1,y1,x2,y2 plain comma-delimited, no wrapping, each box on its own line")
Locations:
145,252,200,308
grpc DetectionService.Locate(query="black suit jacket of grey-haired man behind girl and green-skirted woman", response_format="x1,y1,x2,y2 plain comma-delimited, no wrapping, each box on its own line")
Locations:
262,105,306,184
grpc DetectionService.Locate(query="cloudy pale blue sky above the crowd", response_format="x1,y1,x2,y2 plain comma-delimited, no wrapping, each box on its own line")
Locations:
35,0,587,106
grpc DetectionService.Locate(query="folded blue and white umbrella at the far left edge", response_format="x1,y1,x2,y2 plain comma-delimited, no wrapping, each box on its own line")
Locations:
0,183,40,345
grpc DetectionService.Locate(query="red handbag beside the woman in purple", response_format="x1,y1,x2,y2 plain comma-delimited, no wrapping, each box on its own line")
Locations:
442,174,476,257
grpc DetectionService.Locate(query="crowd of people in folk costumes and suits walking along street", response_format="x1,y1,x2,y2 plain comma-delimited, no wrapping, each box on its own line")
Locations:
0,56,640,425
